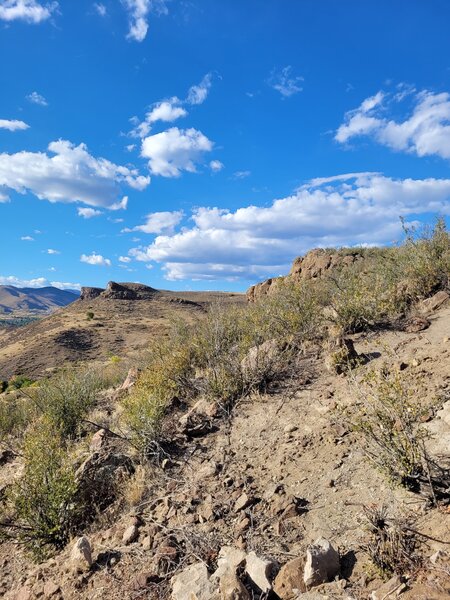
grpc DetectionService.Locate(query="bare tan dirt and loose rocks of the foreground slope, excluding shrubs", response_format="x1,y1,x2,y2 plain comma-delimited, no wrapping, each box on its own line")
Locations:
0,292,450,600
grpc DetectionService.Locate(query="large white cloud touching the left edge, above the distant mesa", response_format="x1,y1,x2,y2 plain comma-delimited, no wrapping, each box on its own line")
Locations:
0,140,150,210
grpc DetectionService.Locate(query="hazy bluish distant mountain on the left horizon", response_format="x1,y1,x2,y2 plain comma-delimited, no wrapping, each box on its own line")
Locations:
0,285,79,314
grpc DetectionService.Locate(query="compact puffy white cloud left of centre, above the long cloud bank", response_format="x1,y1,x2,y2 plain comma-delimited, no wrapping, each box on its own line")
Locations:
141,127,213,177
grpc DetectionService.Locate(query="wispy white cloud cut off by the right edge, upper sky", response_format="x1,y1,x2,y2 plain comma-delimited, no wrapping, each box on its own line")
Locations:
335,86,450,158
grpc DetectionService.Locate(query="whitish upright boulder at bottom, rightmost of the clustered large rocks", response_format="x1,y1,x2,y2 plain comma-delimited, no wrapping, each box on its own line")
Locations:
303,537,340,588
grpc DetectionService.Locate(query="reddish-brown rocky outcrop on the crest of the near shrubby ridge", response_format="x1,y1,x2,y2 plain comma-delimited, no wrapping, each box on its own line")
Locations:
247,248,363,302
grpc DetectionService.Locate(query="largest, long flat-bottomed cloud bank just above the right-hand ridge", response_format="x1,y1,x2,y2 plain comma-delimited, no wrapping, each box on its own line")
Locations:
129,173,450,280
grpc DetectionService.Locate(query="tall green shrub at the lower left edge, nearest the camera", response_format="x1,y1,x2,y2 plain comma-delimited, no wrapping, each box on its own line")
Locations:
2,419,81,559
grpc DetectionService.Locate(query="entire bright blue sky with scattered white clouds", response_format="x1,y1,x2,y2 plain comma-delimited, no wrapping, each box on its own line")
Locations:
0,0,450,290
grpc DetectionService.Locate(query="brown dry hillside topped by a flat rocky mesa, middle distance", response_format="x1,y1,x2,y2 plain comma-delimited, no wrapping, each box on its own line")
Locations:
0,282,245,380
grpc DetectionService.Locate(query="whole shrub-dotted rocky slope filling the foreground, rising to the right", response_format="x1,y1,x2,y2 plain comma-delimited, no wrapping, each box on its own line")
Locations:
0,222,450,600
